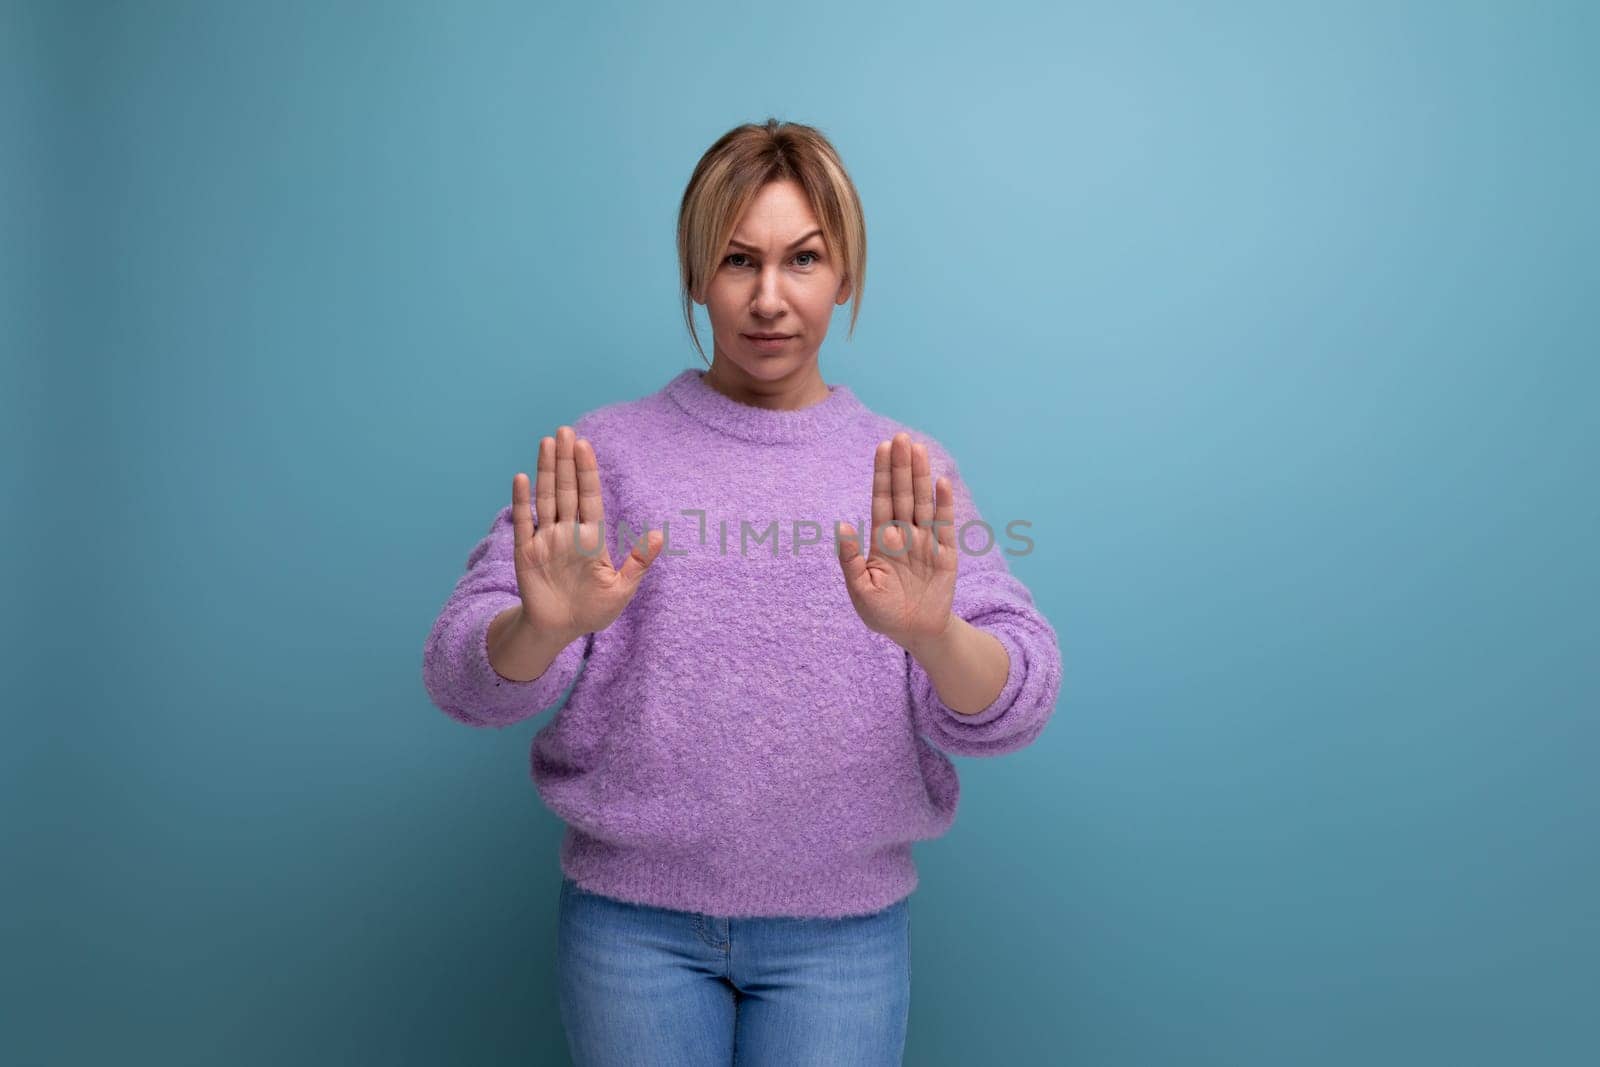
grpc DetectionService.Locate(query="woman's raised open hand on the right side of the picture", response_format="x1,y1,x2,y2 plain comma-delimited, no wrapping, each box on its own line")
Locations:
835,432,957,651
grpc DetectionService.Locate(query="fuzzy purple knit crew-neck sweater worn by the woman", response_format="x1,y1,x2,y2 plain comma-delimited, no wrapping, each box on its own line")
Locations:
422,368,1061,918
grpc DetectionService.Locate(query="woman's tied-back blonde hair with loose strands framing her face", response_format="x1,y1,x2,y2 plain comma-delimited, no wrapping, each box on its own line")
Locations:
678,118,867,366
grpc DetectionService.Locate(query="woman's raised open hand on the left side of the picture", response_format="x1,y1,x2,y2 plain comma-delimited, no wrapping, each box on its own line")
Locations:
510,426,662,640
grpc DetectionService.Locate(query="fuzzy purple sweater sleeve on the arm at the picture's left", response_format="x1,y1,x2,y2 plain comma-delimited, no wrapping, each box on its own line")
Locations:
422,504,594,726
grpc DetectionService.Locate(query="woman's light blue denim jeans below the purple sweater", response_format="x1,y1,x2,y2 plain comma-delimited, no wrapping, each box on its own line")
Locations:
555,875,910,1067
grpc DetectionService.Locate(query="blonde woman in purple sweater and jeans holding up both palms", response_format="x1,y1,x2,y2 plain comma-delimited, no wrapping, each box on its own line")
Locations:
424,120,1061,1065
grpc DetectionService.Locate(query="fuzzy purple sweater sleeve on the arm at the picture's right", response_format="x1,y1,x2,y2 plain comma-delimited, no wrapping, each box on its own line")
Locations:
906,435,1061,757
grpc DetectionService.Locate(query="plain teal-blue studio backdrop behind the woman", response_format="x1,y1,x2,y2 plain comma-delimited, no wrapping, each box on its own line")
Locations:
0,2,1600,1065
